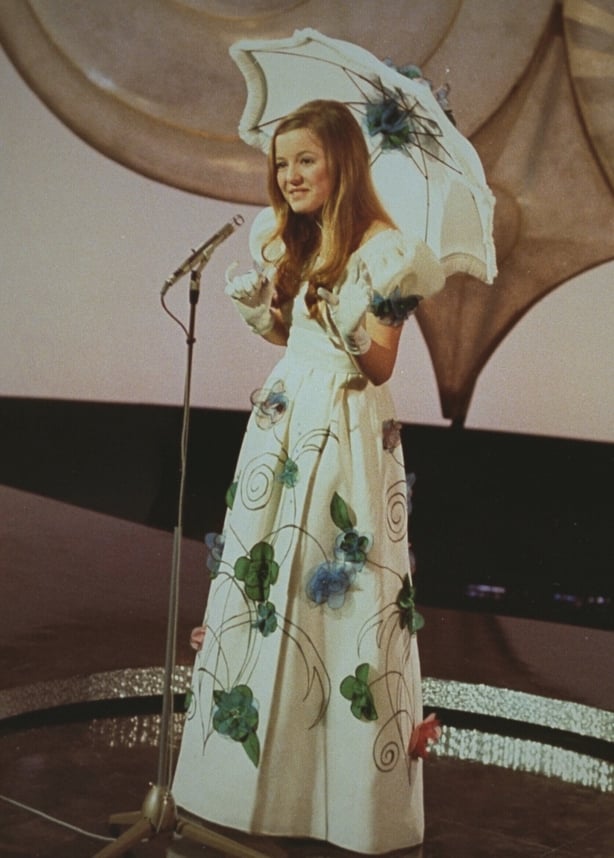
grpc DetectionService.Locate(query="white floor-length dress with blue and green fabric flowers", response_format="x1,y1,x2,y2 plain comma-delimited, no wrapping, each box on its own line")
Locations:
173,209,443,854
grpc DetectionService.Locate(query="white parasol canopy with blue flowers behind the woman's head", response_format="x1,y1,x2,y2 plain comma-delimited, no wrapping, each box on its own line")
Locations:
230,29,497,283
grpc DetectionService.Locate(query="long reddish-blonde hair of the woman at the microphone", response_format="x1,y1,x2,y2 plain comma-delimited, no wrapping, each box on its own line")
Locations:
263,99,394,313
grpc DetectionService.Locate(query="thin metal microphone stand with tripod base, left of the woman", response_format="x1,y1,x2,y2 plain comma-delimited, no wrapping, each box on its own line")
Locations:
94,260,267,858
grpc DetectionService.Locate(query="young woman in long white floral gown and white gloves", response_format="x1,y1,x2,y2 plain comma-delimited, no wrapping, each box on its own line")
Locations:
173,101,444,854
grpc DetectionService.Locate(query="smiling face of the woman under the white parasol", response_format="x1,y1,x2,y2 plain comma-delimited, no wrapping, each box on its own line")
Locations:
275,128,333,214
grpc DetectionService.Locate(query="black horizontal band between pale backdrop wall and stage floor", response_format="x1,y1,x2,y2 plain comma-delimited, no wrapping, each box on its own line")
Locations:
0,398,614,629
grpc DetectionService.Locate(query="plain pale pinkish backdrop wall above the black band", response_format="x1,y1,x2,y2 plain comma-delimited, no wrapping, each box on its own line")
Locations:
0,44,614,441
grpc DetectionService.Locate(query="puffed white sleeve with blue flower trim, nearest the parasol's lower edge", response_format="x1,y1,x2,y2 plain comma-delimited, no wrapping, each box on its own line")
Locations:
361,231,446,325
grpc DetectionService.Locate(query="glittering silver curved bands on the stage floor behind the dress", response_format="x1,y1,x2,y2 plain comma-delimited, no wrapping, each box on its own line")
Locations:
0,665,614,792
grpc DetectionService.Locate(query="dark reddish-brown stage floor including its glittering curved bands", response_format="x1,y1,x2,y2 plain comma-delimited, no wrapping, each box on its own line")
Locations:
0,487,614,858
